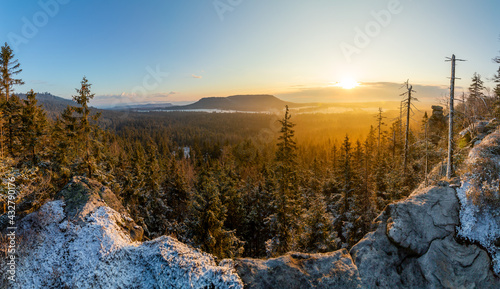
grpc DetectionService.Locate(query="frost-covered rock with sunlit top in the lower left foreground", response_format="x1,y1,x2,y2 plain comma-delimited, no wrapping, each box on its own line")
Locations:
1,178,243,288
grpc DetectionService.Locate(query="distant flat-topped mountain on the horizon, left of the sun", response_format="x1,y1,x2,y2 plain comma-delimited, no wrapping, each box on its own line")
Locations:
169,94,297,111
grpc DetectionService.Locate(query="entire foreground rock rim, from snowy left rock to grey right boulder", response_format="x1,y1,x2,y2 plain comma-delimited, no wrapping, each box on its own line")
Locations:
5,153,500,289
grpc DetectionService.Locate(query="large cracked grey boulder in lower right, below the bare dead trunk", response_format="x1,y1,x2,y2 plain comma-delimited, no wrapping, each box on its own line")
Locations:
350,184,500,288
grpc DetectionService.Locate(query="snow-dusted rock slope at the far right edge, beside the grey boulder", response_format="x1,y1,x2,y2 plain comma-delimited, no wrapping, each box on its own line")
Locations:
457,131,500,275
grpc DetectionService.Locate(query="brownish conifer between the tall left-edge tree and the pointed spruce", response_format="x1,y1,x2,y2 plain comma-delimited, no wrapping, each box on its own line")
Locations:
21,90,47,164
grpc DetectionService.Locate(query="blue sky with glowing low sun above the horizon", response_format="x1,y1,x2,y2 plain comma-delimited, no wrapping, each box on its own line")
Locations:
0,0,500,107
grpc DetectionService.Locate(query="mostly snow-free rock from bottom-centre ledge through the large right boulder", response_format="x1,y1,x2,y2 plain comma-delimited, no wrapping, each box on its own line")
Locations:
236,182,500,288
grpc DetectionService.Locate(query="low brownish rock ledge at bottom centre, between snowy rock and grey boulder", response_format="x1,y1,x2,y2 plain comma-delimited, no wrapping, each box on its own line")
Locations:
236,249,362,289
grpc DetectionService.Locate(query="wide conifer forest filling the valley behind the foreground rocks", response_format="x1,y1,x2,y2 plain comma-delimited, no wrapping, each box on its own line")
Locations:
0,44,500,258
